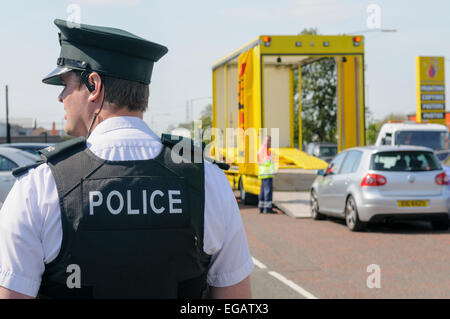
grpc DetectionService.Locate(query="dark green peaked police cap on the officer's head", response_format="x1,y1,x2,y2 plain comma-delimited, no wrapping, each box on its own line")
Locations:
42,19,168,85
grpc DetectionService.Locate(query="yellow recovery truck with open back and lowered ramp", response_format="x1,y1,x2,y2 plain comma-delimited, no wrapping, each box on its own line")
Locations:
211,35,365,203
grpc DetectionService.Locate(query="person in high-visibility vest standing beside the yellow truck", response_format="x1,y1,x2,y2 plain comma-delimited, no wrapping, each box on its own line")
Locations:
258,136,275,214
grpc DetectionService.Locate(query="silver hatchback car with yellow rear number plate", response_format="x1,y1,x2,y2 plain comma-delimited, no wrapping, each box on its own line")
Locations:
310,146,450,231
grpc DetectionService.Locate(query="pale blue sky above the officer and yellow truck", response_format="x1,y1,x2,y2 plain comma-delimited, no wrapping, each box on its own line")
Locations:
0,0,450,132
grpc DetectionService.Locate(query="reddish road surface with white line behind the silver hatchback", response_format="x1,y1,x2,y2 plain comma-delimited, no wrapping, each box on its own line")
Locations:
240,199,450,299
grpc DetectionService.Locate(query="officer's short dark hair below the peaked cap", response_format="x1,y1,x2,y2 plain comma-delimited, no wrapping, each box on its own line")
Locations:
74,70,150,112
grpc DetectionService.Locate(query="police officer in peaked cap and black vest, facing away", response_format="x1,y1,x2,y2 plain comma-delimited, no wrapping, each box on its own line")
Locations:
0,20,253,298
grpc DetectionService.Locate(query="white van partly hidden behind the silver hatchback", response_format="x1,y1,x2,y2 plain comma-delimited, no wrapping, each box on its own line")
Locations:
375,122,448,151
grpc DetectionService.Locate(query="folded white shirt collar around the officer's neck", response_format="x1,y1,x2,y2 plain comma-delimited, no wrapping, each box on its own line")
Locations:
87,116,159,142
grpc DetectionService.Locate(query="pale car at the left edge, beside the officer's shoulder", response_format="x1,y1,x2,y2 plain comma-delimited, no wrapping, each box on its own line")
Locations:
0,147,39,207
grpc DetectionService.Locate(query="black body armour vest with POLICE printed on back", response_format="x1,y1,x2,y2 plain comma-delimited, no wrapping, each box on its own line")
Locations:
29,138,211,298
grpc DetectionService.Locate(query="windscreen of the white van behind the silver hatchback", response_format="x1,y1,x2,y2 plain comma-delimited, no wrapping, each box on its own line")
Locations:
395,131,448,150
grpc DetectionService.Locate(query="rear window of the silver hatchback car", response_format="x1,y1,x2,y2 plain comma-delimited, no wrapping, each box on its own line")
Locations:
370,151,442,172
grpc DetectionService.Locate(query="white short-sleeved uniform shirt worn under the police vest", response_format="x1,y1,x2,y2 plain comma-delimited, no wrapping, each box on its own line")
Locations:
0,117,253,297
